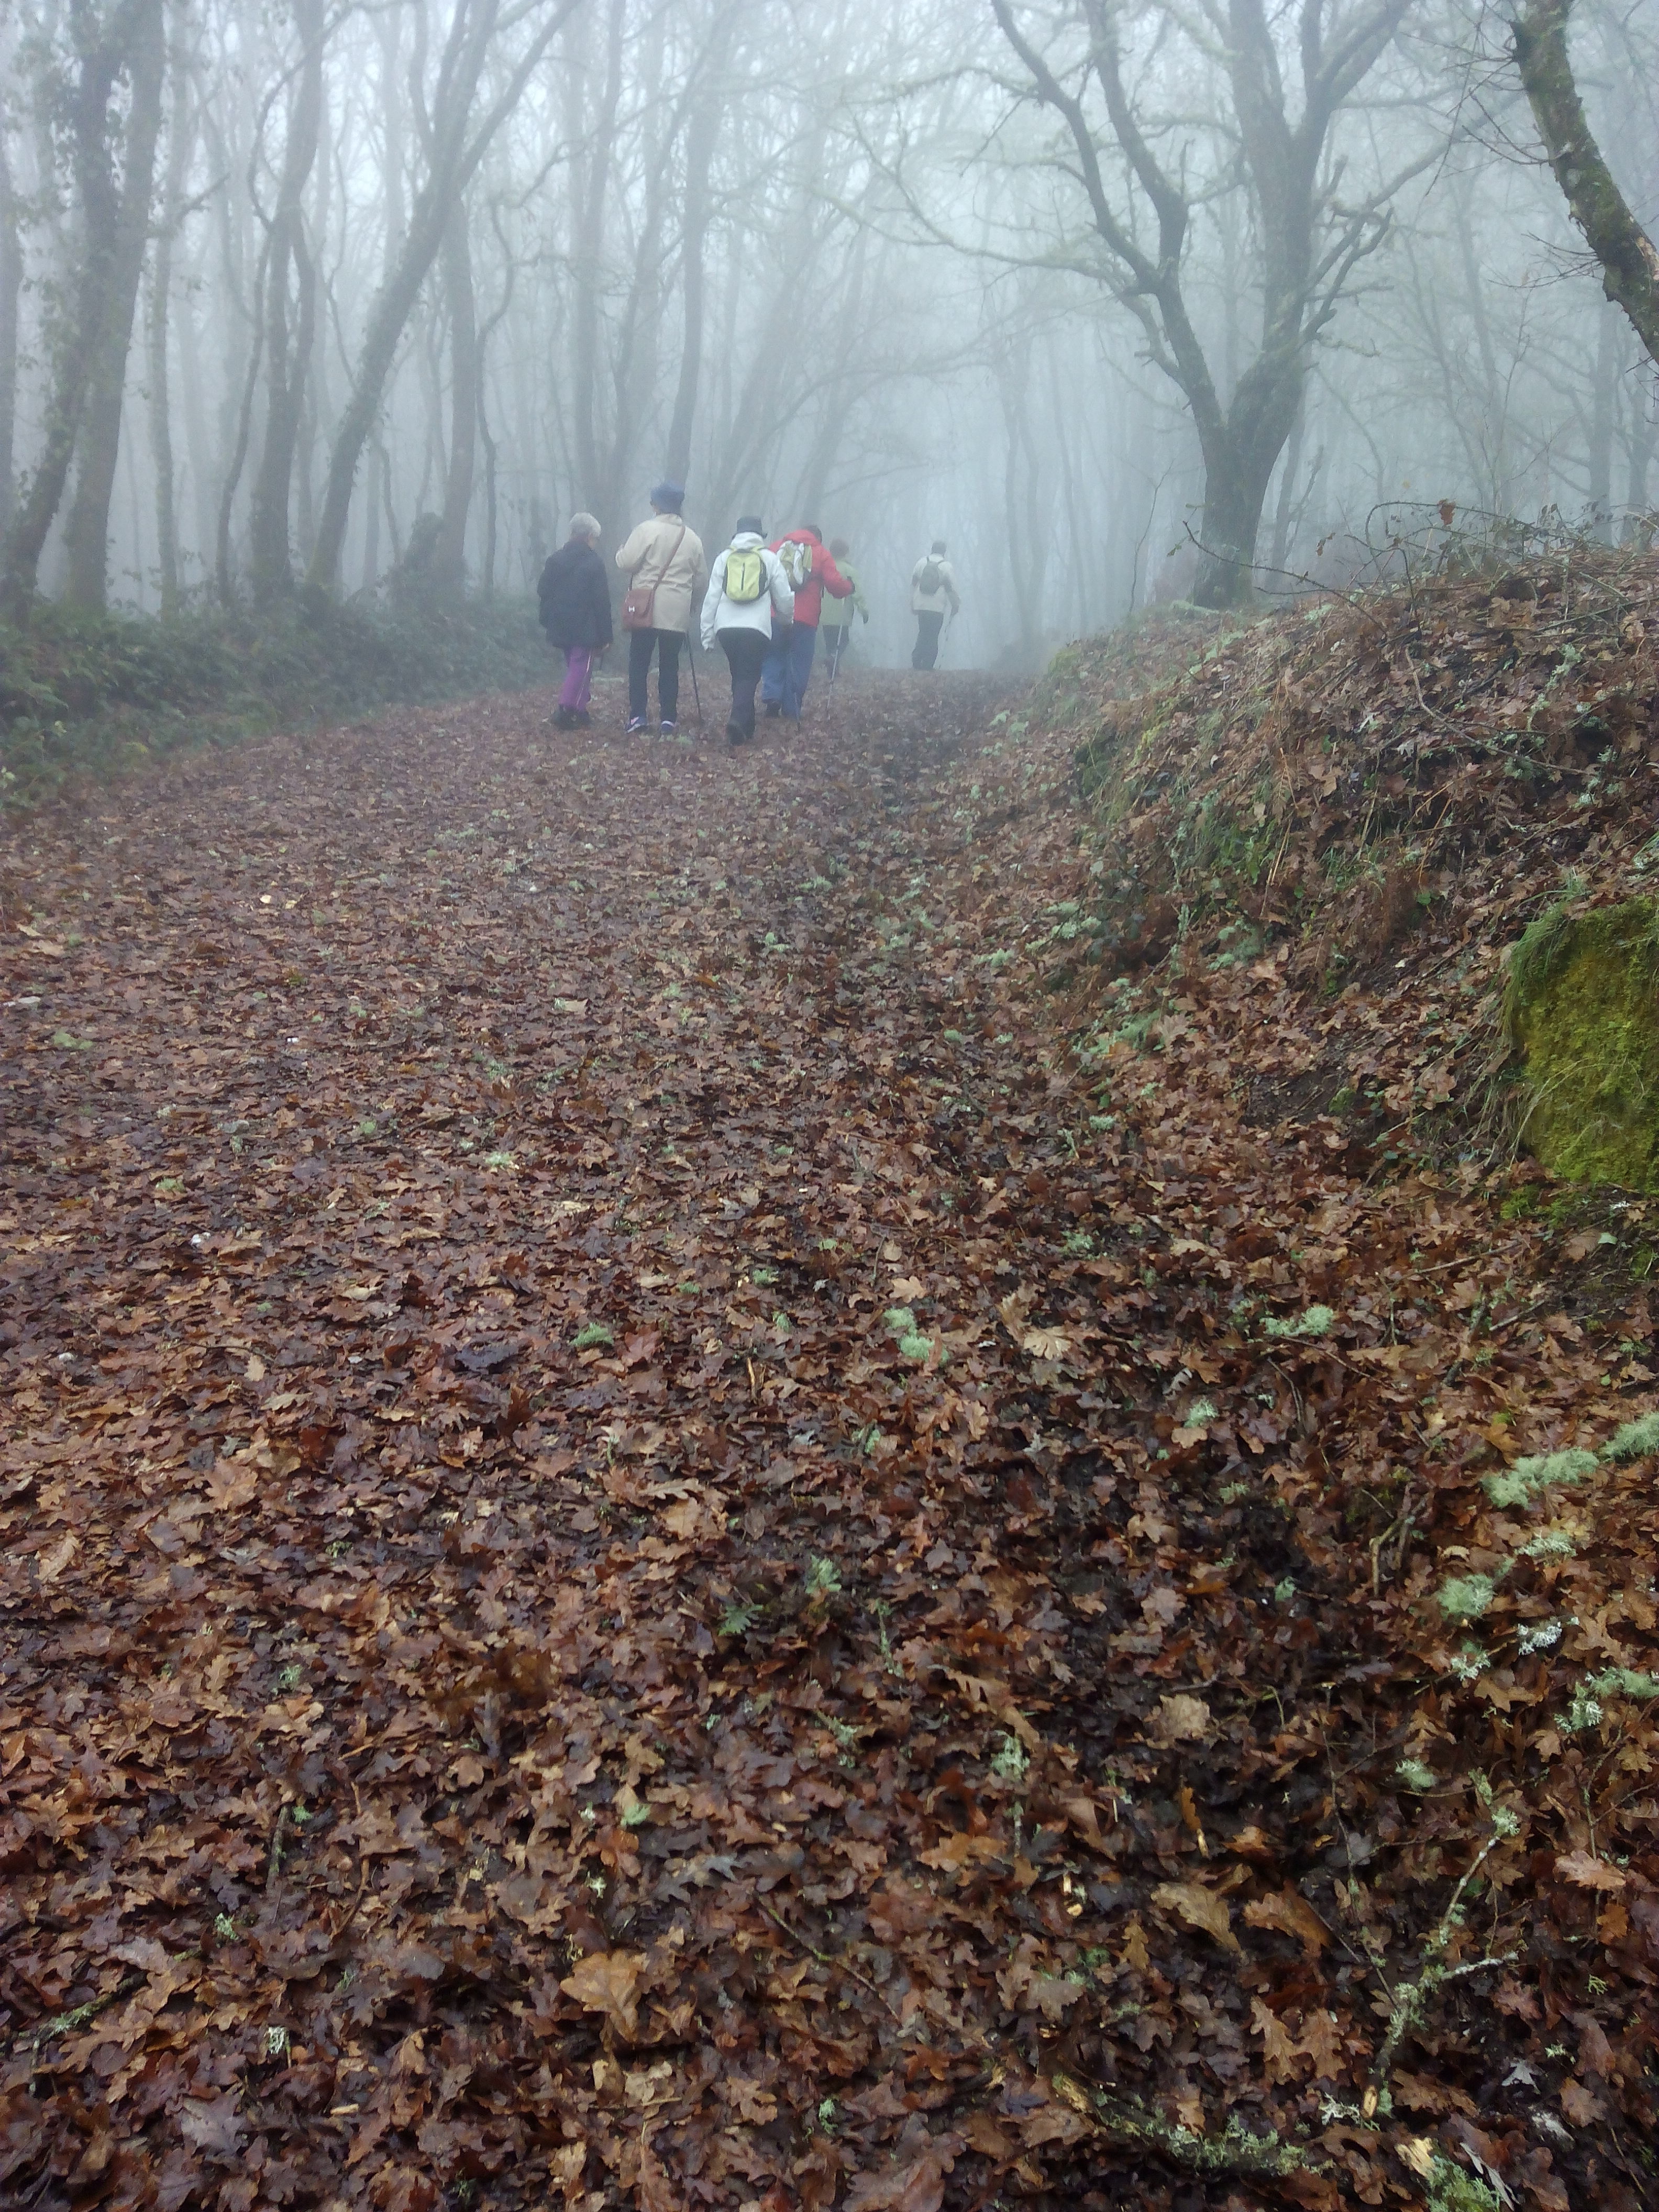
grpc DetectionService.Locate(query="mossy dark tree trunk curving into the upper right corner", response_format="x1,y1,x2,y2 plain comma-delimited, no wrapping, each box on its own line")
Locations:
1511,0,1659,361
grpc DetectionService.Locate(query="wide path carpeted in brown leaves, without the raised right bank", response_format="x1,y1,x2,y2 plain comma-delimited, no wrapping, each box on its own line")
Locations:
0,677,1635,2212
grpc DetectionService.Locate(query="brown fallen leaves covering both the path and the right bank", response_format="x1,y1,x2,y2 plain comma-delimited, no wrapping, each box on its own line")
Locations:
0,586,1659,2212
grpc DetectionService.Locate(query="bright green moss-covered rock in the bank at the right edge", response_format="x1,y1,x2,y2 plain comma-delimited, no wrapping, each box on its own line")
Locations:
1504,898,1659,1190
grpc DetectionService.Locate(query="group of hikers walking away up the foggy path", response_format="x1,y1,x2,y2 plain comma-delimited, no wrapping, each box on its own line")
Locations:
537,482,962,745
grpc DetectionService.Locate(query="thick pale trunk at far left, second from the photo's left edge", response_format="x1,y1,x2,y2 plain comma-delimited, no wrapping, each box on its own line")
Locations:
64,0,166,609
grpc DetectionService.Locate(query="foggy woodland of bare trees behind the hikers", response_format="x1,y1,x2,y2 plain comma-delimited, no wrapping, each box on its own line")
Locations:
0,0,1659,666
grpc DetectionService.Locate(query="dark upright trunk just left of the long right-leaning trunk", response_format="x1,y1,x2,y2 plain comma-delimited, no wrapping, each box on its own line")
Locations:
248,0,323,604
